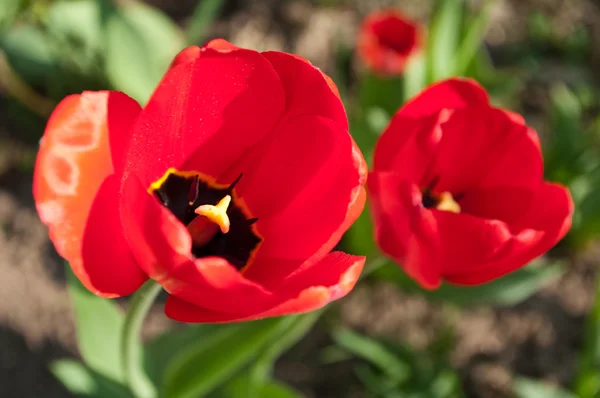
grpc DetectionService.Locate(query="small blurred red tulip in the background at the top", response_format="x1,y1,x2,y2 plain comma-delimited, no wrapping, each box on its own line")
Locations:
357,10,421,75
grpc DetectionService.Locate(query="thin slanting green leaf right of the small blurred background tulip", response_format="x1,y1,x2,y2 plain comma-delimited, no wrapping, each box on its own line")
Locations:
454,0,494,76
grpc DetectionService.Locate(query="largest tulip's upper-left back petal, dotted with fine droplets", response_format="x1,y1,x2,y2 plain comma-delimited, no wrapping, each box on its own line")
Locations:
122,44,285,186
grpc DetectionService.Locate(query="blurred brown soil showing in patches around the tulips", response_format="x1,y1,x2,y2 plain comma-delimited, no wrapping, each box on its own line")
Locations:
0,0,600,398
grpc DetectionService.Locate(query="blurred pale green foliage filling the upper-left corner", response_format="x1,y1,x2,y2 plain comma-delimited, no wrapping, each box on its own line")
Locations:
0,0,189,103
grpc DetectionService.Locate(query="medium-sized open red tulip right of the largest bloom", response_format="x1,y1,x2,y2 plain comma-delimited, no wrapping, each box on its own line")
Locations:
368,79,573,288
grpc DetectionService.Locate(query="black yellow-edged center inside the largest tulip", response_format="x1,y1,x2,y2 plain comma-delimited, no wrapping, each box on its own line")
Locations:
150,169,262,270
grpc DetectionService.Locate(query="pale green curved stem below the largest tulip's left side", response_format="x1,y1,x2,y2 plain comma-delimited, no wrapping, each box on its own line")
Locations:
121,280,161,398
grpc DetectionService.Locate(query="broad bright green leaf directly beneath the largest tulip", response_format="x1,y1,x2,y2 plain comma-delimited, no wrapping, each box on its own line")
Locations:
163,317,293,398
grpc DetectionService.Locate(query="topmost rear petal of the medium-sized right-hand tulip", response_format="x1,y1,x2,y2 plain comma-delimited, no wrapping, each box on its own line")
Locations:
398,78,489,118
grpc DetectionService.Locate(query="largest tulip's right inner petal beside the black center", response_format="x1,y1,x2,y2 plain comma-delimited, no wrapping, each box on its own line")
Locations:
218,116,365,286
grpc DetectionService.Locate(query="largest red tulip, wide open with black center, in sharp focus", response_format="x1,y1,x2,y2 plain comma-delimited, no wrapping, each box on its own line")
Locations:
34,40,366,322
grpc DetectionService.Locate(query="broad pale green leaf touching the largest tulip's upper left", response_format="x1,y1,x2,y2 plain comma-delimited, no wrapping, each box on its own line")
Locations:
105,2,185,104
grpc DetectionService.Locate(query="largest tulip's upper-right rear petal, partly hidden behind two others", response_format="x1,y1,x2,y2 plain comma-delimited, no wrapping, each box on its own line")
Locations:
263,51,348,130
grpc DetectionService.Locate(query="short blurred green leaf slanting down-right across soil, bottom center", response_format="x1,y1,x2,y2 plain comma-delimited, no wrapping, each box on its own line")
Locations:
333,329,410,382
